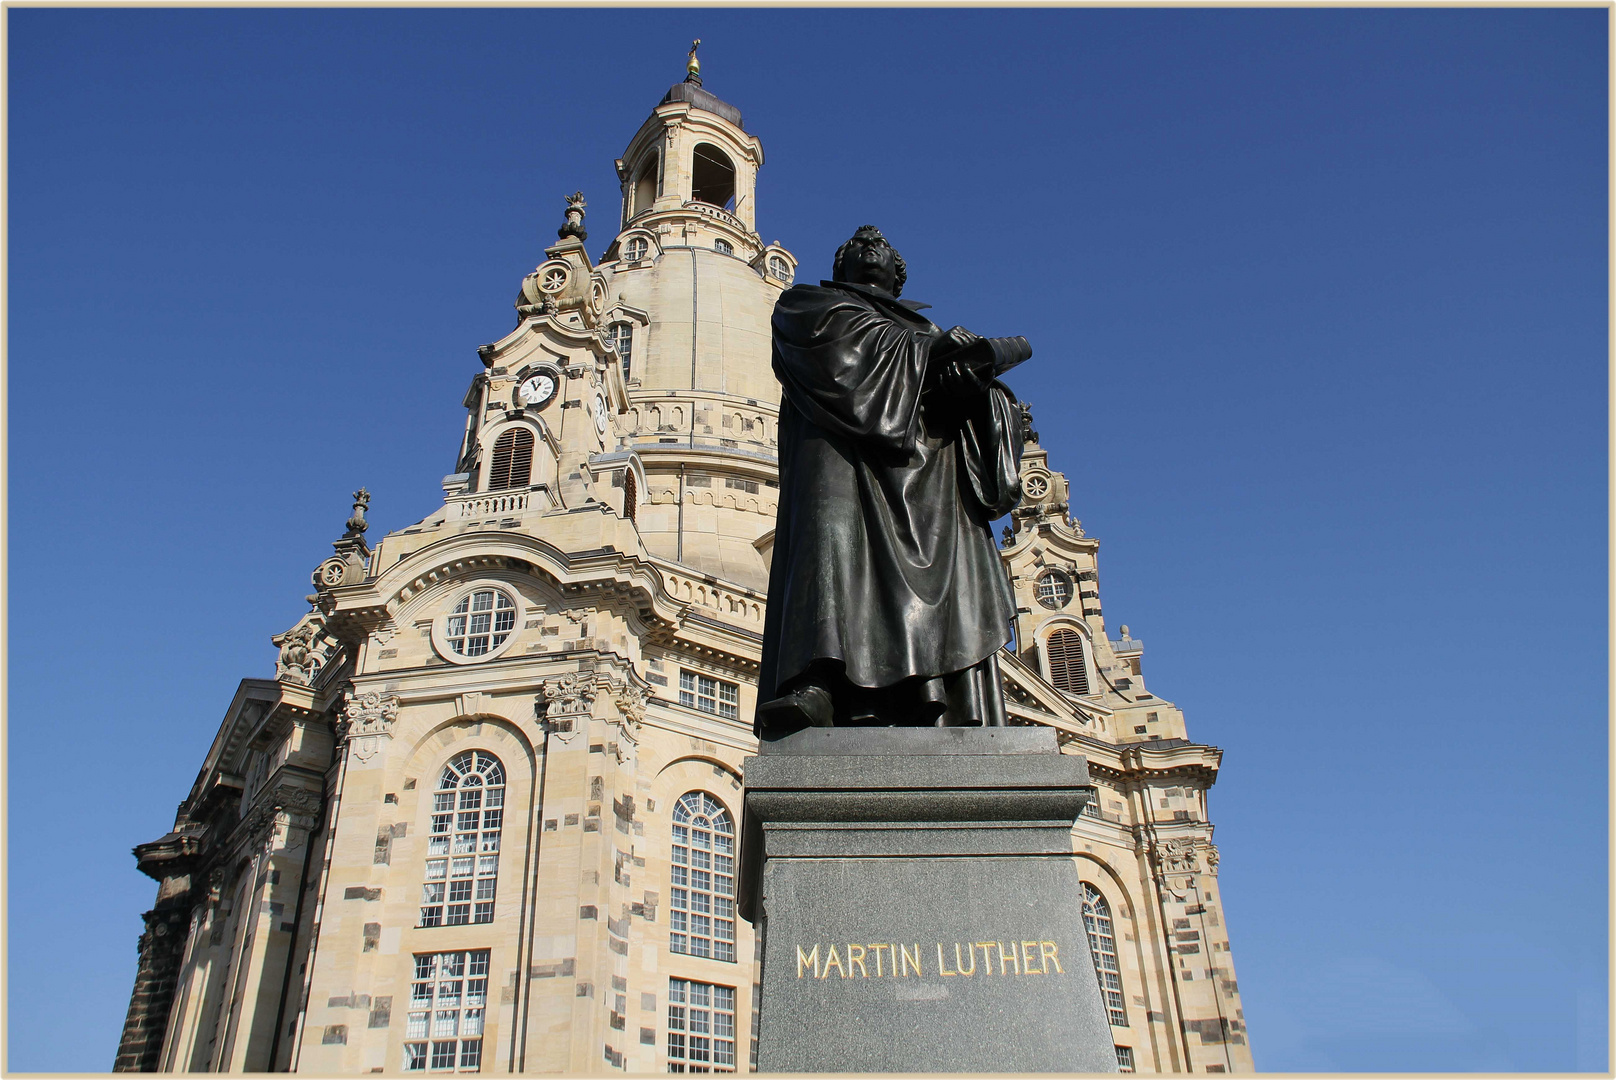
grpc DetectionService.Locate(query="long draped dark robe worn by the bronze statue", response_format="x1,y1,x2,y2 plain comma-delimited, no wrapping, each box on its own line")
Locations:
758,281,1023,721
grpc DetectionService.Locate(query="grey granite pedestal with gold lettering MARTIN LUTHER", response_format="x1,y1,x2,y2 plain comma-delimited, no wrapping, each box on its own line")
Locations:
739,728,1117,1074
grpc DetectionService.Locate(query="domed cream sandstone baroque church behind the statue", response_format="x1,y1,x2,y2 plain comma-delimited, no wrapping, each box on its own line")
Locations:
115,50,1252,1075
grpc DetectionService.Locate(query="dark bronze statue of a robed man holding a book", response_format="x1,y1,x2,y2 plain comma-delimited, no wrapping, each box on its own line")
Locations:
755,225,1033,740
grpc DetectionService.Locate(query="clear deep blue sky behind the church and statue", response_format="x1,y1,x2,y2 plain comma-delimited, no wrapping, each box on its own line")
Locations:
6,8,1608,1072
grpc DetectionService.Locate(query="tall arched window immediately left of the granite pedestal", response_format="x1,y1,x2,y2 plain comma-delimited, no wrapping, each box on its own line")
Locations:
667,791,735,964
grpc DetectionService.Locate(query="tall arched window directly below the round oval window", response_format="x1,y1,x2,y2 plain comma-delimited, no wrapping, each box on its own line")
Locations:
420,750,504,926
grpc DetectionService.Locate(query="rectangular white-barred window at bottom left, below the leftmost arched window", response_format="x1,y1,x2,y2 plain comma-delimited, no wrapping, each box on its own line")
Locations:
404,949,488,1072
